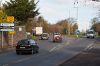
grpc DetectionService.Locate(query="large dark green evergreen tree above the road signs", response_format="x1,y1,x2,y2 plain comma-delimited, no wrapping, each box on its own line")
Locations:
3,0,39,24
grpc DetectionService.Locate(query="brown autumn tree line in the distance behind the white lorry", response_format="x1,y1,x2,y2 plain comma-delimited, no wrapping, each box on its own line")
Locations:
26,16,78,34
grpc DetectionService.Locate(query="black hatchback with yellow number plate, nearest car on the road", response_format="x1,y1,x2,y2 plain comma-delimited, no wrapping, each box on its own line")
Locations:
16,39,39,54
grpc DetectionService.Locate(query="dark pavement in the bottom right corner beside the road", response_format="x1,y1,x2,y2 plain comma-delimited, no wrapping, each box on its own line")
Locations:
59,38,100,66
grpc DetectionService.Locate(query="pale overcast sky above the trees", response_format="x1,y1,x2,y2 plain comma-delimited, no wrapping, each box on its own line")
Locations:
3,0,100,30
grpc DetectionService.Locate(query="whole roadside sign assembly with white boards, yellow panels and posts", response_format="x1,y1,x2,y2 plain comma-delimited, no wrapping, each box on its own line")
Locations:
0,16,14,48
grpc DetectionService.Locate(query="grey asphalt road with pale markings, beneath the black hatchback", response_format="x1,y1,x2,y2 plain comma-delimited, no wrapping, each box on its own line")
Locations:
0,37,94,66
